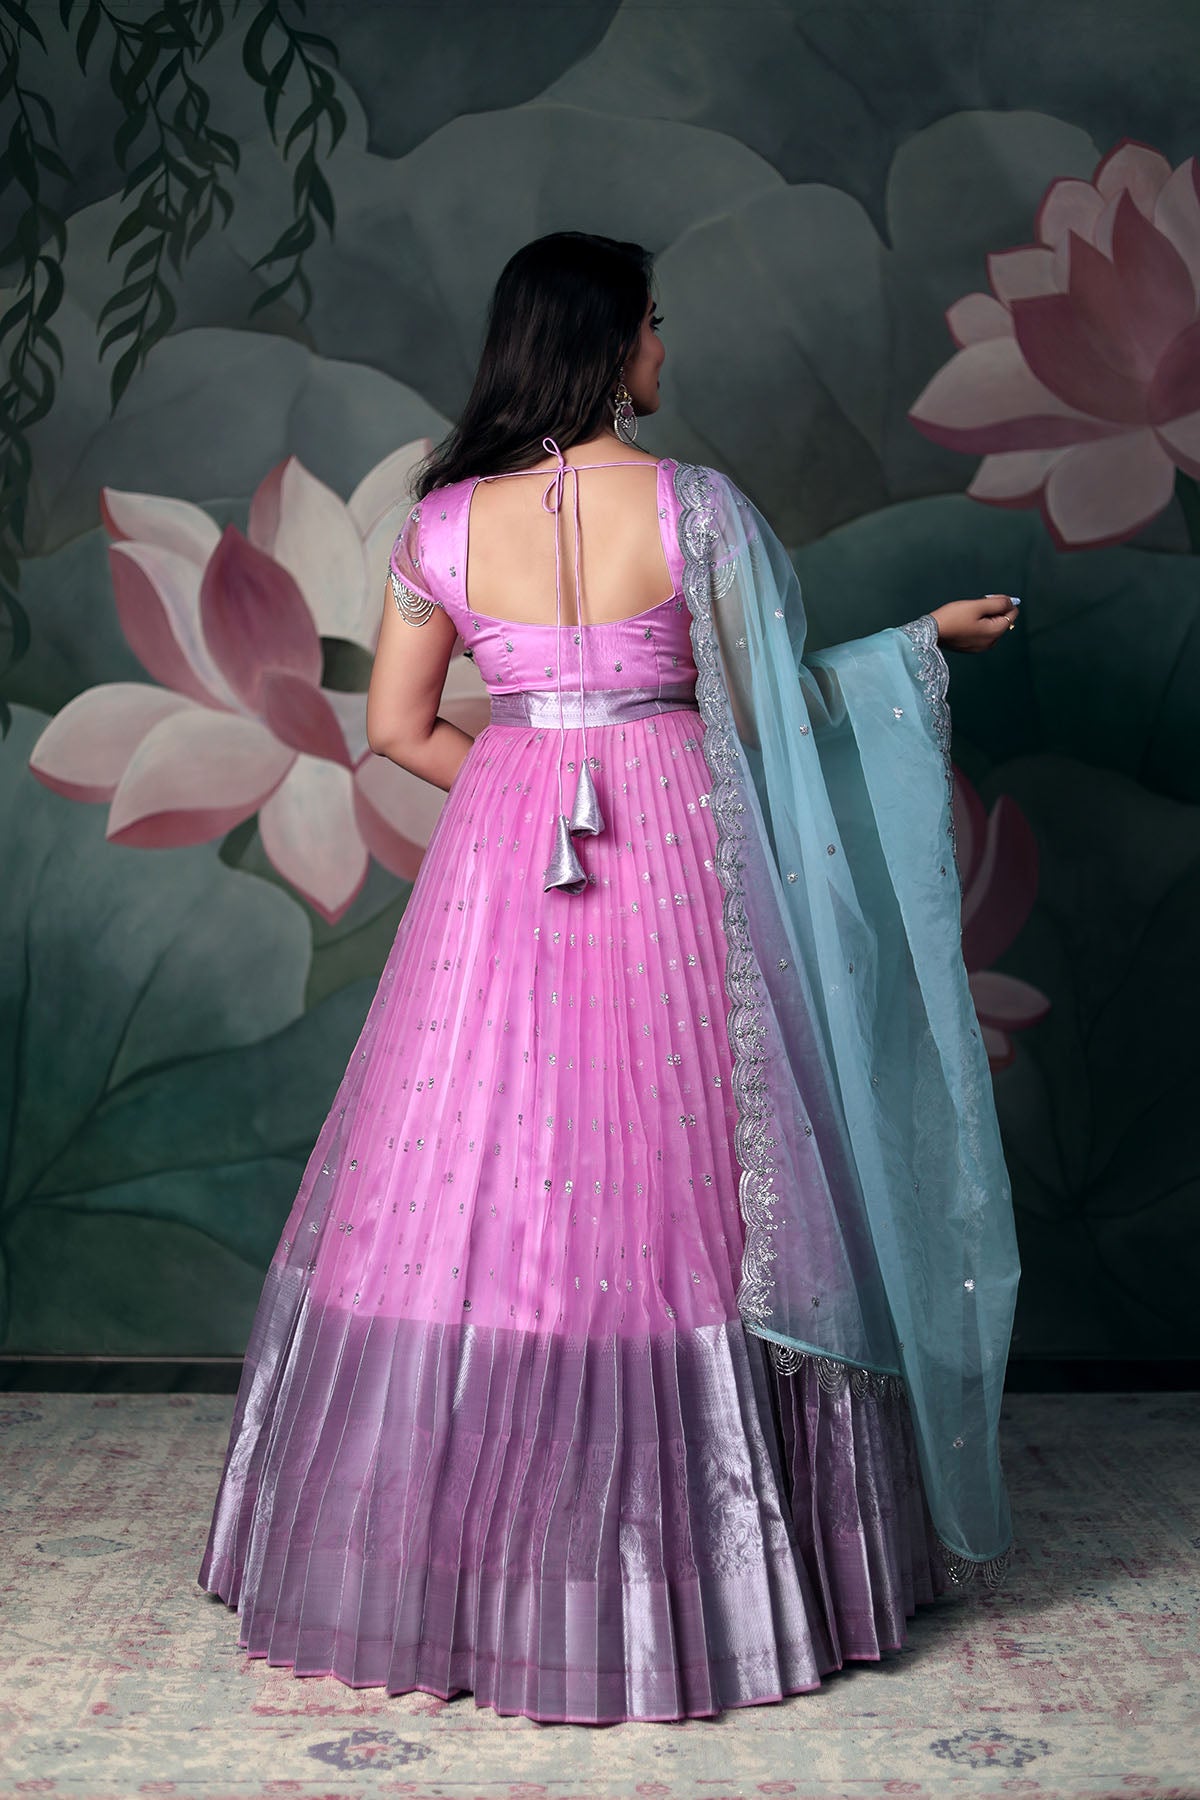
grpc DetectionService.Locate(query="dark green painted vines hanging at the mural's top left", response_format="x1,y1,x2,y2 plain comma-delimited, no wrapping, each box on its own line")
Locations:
0,0,345,734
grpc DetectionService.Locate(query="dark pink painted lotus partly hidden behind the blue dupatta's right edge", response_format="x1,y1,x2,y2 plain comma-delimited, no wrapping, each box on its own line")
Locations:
954,769,1051,1069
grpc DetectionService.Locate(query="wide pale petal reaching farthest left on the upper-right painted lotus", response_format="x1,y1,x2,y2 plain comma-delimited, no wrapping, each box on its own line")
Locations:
909,336,1115,455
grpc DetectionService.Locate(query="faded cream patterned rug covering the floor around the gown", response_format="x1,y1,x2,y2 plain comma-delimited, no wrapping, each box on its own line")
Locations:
0,1393,1200,1800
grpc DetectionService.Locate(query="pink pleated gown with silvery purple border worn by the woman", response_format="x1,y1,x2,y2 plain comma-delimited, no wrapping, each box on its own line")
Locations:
200,463,945,1723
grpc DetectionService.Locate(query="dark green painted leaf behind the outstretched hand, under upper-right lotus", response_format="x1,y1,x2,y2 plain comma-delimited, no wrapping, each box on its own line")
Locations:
795,495,1200,803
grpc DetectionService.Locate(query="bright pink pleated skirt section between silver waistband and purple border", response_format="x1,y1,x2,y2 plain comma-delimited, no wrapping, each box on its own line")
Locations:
300,702,741,1336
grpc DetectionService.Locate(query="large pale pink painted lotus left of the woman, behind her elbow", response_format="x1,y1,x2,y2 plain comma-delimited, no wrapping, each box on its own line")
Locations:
31,443,488,922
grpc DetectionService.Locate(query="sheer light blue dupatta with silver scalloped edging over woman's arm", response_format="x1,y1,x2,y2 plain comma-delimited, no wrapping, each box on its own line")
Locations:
675,464,1018,1582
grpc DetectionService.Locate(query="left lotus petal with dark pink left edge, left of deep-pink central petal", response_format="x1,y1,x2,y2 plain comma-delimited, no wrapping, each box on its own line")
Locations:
108,542,237,709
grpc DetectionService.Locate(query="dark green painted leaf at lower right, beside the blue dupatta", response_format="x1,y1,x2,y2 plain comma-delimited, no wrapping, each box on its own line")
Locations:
984,756,1200,1359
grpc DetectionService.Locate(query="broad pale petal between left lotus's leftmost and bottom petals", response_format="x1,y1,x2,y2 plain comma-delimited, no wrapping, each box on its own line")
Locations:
108,707,295,850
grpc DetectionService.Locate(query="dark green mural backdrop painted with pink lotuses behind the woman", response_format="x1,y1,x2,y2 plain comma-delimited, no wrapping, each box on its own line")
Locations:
0,0,1200,1357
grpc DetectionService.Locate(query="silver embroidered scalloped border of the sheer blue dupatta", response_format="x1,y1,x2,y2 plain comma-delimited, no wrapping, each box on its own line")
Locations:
675,463,1013,1588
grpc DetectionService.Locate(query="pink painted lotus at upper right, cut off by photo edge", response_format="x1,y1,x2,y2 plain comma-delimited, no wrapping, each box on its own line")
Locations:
909,140,1200,549
